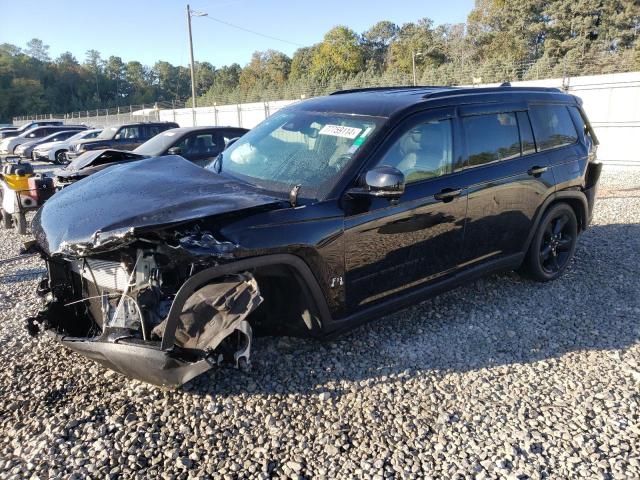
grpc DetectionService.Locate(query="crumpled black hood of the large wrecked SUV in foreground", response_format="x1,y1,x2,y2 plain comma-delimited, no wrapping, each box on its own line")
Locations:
32,155,281,255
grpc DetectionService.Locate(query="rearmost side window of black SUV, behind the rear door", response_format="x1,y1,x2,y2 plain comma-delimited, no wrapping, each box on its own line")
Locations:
529,105,578,151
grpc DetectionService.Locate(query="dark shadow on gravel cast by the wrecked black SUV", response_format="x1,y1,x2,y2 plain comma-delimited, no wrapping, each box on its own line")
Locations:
182,224,640,397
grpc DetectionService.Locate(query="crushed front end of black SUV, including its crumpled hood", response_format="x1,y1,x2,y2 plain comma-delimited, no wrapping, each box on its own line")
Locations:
23,155,281,385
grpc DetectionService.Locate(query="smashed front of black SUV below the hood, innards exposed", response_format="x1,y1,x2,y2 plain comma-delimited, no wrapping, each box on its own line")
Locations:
27,228,262,386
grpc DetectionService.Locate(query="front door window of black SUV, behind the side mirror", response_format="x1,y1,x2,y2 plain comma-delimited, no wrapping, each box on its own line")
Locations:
378,120,453,183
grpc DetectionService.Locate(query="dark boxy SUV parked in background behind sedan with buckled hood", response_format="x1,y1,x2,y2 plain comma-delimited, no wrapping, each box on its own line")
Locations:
67,122,179,160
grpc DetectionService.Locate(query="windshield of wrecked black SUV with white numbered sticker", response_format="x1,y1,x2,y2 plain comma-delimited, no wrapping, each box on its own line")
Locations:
206,110,382,199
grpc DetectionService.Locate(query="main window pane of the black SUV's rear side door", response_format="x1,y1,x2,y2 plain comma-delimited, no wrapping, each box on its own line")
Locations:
462,113,520,167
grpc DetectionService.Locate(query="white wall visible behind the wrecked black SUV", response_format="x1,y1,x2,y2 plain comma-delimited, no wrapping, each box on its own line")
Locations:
159,72,640,167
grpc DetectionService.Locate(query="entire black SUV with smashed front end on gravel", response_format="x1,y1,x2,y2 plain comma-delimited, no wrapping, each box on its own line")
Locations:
28,87,601,385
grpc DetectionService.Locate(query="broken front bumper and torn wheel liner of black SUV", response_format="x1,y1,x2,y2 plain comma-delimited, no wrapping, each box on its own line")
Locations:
27,264,262,386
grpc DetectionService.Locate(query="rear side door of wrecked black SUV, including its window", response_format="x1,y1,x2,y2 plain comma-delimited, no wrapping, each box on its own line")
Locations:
460,105,554,266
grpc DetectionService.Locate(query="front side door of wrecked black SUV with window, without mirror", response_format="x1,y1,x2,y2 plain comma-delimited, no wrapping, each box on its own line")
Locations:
345,109,467,313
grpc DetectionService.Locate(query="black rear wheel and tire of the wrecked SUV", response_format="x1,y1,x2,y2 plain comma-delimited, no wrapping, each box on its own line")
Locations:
523,203,578,282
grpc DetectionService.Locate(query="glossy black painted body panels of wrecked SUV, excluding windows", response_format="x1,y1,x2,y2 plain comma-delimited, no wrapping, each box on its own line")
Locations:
28,87,600,383
